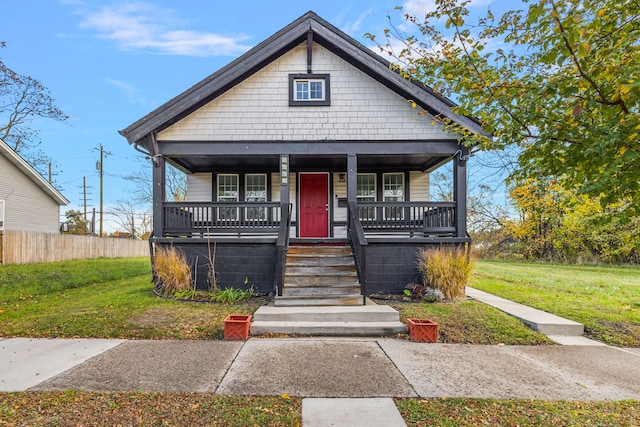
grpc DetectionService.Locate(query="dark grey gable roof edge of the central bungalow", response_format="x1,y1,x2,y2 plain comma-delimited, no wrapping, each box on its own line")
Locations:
120,11,486,148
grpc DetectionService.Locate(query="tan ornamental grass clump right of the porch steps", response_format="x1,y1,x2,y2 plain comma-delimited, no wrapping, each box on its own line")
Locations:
418,248,471,300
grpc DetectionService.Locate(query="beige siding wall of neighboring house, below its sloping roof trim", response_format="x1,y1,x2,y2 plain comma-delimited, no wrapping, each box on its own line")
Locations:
0,154,60,233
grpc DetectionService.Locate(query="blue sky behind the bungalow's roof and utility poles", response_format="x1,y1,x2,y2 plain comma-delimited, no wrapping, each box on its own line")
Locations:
0,0,502,230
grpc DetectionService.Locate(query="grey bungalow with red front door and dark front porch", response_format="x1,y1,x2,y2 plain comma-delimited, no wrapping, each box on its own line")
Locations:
120,12,483,304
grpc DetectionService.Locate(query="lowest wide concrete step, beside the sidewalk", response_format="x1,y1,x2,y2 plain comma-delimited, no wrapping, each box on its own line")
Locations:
249,321,406,337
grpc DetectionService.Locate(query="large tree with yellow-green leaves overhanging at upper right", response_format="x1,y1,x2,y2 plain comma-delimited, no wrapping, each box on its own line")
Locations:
376,0,640,220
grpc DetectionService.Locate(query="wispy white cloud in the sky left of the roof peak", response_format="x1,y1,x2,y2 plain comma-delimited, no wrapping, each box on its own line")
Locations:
80,2,251,56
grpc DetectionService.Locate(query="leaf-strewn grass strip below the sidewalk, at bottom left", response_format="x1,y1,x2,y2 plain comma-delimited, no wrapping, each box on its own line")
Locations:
0,390,302,427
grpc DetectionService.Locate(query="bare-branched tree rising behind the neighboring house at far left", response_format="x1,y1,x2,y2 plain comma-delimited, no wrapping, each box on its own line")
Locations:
0,42,68,162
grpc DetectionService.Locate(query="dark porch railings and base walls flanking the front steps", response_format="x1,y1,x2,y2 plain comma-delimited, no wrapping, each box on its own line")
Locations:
153,201,470,302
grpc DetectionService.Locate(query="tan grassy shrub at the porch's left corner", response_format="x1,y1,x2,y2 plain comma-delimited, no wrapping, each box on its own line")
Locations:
153,246,192,295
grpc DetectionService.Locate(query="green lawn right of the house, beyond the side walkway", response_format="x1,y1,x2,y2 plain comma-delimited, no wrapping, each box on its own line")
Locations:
471,261,640,347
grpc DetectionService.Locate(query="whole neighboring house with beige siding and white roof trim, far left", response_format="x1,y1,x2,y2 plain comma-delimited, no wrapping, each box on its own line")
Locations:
0,139,69,233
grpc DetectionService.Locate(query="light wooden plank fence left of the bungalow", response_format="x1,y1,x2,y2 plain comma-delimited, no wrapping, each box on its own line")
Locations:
0,230,149,264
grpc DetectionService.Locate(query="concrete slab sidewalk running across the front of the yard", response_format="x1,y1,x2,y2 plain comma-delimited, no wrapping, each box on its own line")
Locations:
0,338,640,401
